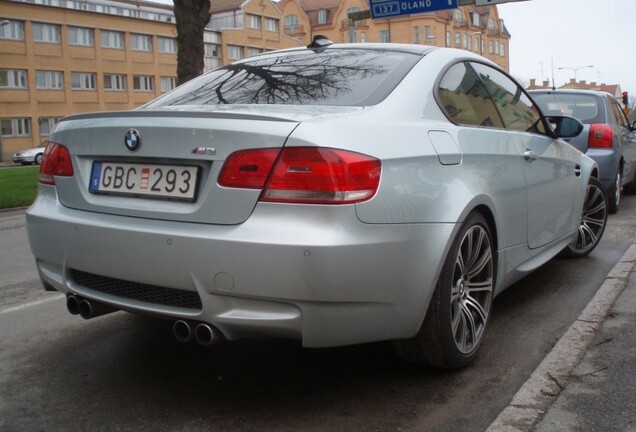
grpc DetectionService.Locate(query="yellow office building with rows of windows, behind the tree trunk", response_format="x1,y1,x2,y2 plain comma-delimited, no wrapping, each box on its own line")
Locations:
0,0,299,161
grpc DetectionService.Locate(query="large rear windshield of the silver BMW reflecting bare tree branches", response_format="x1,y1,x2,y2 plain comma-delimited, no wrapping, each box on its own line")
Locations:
144,49,422,109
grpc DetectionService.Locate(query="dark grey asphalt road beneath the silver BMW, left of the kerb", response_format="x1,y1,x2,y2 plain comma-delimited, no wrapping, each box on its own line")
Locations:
0,196,636,432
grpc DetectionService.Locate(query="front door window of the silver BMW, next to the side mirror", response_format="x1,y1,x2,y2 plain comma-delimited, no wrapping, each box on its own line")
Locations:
471,63,546,133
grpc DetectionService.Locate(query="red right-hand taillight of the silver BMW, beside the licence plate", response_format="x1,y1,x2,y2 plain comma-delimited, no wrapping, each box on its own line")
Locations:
219,147,381,204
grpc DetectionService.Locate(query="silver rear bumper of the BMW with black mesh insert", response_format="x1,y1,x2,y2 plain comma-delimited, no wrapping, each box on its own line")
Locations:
27,186,455,347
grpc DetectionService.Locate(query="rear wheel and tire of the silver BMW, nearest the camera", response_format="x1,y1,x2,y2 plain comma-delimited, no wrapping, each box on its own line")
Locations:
394,213,496,369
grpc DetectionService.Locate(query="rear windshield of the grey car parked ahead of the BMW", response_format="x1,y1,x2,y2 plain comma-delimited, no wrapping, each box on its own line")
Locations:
532,93,605,124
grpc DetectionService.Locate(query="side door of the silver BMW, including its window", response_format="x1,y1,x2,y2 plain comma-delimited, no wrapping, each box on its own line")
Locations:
472,63,581,249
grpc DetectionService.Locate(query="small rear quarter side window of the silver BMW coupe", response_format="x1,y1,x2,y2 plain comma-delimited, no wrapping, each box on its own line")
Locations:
438,63,503,128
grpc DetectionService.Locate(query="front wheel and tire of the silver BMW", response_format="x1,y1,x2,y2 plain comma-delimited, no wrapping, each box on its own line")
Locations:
561,177,609,258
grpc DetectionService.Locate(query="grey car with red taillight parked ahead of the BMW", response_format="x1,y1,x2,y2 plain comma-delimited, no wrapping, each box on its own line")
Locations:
530,90,636,213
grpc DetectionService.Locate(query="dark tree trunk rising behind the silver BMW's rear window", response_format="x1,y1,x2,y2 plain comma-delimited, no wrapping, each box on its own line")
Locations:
173,0,210,85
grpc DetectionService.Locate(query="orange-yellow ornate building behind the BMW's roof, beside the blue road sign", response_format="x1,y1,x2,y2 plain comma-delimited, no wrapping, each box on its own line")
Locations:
278,0,510,70
